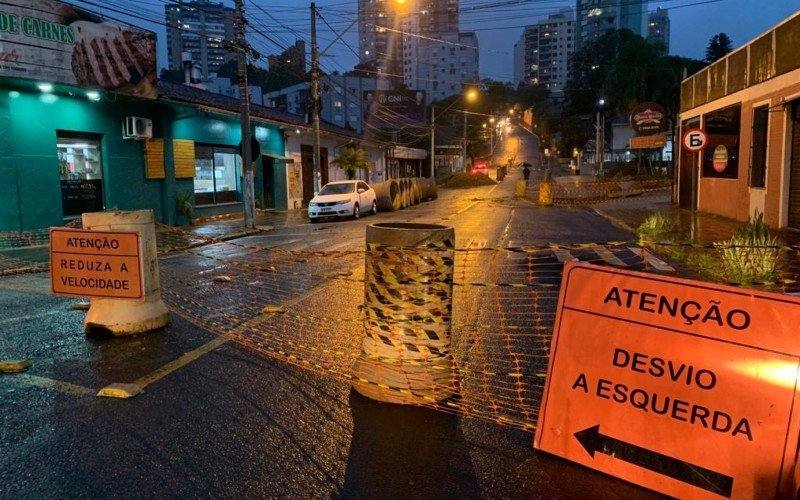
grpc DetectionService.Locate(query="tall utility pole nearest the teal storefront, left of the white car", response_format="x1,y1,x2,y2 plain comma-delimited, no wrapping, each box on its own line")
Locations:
235,0,255,228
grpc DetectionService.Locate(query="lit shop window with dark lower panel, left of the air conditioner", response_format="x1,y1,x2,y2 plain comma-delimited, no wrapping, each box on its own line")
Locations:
56,132,103,217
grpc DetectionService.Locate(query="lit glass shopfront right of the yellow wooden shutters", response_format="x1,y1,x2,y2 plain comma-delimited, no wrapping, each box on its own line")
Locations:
194,145,241,205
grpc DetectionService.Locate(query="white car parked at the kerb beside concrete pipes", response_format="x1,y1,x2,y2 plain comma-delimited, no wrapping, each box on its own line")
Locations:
308,181,378,222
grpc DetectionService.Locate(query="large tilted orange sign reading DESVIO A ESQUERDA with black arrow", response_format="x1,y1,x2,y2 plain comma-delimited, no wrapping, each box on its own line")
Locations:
534,263,800,498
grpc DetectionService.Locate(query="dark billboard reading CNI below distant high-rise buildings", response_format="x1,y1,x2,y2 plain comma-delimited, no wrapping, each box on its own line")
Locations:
364,90,425,128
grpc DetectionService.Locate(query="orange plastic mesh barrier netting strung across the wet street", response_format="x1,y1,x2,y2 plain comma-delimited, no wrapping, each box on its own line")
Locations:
0,217,800,430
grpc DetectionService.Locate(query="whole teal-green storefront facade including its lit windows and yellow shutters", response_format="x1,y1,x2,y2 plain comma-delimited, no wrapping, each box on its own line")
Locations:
0,79,288,231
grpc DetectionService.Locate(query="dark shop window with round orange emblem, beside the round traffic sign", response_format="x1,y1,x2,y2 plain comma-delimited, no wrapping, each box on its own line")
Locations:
703,104,742,179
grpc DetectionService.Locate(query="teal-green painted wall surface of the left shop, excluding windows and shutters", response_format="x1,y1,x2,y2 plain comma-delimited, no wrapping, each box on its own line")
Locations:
0,88,285,231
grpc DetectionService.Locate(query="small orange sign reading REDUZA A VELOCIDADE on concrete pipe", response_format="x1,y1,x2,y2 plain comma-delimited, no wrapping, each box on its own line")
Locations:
50,228,144,299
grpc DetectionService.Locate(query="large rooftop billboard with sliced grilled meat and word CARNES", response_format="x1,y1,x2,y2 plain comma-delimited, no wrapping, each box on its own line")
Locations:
0,0,156,98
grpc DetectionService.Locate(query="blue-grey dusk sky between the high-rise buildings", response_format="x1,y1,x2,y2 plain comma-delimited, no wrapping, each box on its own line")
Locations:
75,0,800,80
